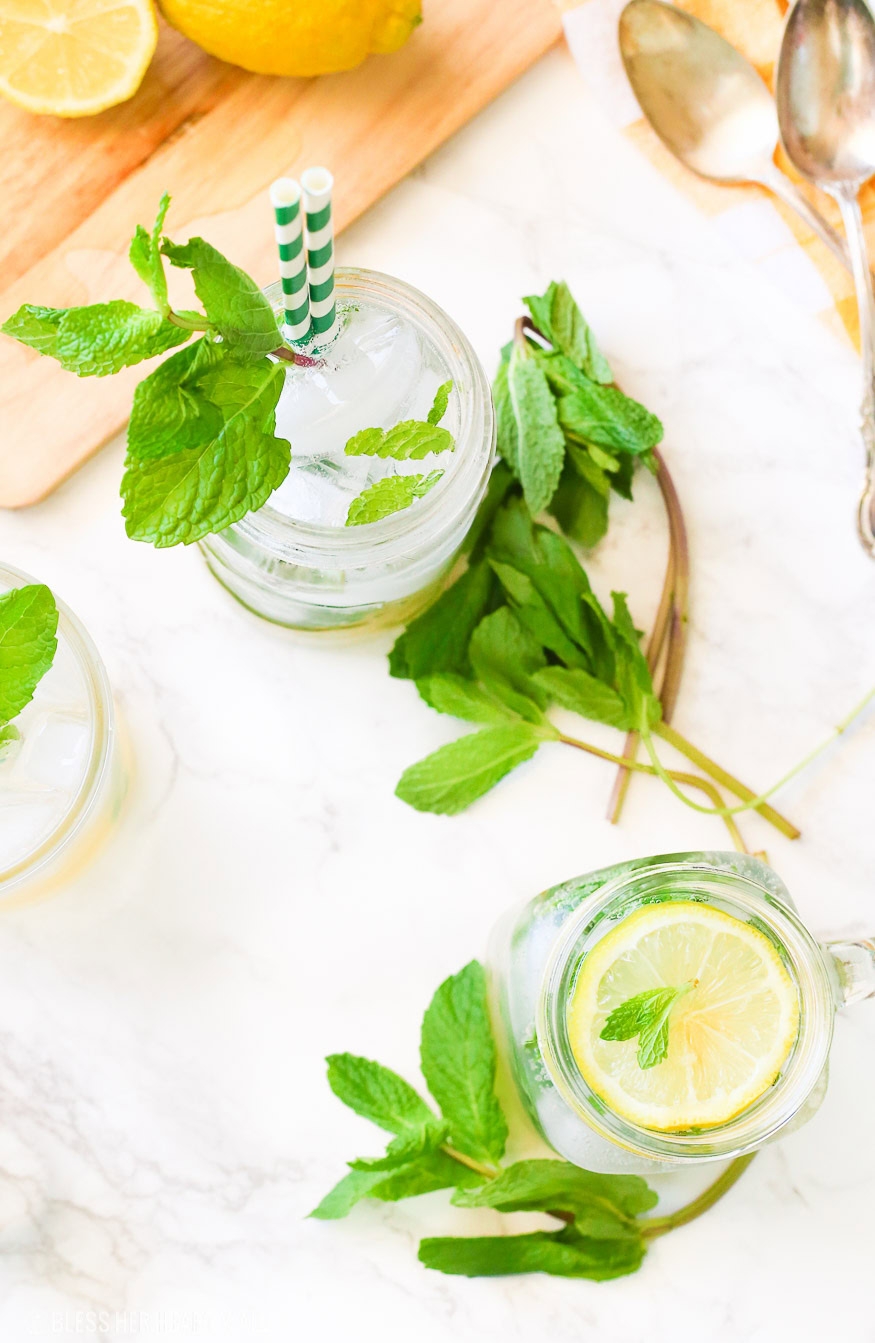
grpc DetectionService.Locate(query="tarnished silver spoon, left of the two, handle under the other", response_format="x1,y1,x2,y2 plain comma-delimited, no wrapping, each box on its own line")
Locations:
619,0,851,270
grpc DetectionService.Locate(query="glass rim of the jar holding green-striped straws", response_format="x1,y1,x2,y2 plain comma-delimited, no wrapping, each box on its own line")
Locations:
228,266,495,567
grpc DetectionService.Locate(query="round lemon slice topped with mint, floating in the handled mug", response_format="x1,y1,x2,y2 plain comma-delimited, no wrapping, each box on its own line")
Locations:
568,901,799,1131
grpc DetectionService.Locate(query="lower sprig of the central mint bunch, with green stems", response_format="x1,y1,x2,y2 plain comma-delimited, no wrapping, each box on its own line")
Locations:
389,480,799,837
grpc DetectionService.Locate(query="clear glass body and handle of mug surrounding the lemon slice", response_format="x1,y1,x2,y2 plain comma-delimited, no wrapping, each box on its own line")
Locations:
488,853,875,1174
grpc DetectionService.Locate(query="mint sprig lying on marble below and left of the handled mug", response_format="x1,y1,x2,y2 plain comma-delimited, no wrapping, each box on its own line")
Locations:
316,962,750,1280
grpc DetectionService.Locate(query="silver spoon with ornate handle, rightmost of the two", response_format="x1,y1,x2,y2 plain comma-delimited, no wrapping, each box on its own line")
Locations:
777,0,875,557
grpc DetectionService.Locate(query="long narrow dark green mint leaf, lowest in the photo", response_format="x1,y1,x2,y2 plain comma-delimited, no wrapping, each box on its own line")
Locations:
419,1228,646,1283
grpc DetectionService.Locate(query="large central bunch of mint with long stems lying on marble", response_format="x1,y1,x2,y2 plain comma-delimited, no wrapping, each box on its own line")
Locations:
389,282,799,847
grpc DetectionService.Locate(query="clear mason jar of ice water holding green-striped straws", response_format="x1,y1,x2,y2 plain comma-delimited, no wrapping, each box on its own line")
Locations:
200,269,495,630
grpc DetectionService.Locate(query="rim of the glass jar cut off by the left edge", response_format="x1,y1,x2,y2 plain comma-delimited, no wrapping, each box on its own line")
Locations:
0,564,115,898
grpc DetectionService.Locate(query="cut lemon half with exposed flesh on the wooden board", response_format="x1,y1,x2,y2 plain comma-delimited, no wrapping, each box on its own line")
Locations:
0,0,158,117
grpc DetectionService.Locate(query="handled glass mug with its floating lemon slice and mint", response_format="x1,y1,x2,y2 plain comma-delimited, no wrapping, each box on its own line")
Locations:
488,853,875,1174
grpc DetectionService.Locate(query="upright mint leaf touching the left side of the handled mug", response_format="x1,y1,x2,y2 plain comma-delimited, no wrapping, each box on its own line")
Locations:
420,960,507,1162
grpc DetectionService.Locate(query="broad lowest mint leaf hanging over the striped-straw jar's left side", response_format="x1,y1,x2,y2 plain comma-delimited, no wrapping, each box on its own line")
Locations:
122,351,291,547
